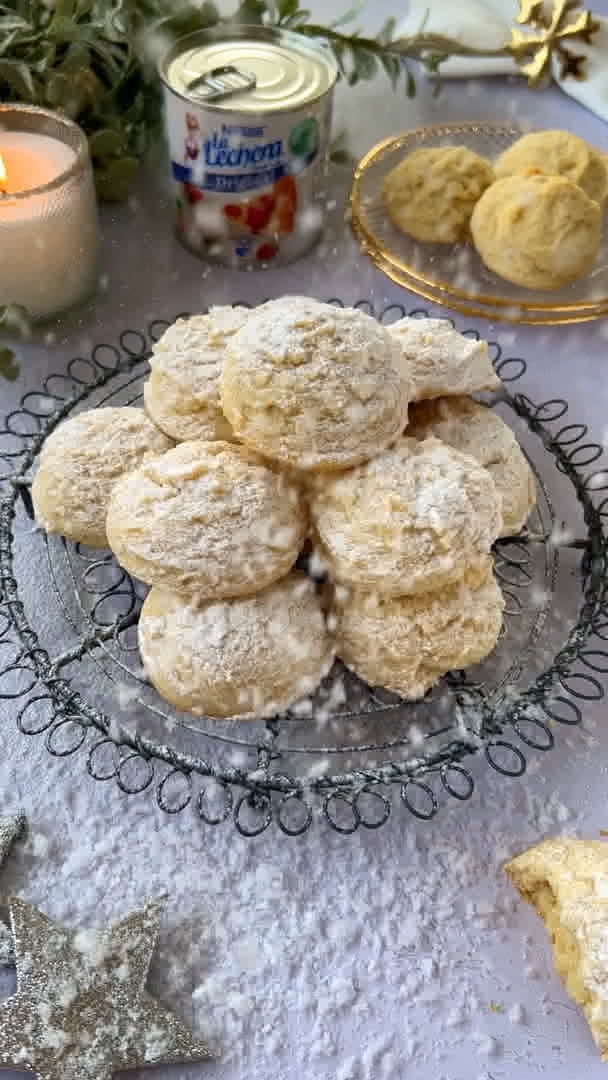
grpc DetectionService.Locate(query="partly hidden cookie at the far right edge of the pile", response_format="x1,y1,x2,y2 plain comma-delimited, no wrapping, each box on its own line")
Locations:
407,397,537,536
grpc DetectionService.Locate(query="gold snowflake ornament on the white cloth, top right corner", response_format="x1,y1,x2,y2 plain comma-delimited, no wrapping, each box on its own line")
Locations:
509,0,599,86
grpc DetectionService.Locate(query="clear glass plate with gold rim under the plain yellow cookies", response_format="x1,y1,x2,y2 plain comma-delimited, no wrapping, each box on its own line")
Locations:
351,123,608,324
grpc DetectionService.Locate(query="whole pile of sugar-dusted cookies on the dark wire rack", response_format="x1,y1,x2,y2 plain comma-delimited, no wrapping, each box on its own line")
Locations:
32,297,535,718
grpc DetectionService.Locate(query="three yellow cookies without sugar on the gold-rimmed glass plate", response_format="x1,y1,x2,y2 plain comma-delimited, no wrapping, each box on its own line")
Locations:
382,131,608,291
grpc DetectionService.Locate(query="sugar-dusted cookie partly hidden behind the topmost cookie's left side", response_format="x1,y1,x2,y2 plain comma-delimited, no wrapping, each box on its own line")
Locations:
144,307,247,443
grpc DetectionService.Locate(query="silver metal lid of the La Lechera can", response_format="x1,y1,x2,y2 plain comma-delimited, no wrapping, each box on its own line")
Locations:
160,26,338,113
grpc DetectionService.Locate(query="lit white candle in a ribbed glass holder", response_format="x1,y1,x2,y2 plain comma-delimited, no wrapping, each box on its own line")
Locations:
0,105,98,320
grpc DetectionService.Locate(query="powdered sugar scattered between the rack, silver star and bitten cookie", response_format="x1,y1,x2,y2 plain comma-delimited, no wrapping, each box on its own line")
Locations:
2,712,586,1080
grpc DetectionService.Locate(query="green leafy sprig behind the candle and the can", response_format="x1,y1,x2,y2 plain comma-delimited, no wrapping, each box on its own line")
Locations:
0,0,511,200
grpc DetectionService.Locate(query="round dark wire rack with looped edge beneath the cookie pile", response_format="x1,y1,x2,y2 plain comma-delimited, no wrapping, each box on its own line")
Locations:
0,300,608,836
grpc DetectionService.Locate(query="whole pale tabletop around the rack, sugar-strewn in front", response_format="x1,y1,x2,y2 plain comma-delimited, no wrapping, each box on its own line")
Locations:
0,0,608,1080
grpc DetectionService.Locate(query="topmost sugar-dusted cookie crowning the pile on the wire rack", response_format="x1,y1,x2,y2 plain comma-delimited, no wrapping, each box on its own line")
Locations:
220,296,408,470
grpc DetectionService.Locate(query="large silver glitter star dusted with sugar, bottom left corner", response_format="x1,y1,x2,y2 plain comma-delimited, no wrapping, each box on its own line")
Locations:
0,899,211,1080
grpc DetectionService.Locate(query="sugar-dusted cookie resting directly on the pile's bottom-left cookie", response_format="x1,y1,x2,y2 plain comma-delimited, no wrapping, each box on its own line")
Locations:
107,441,307,599
